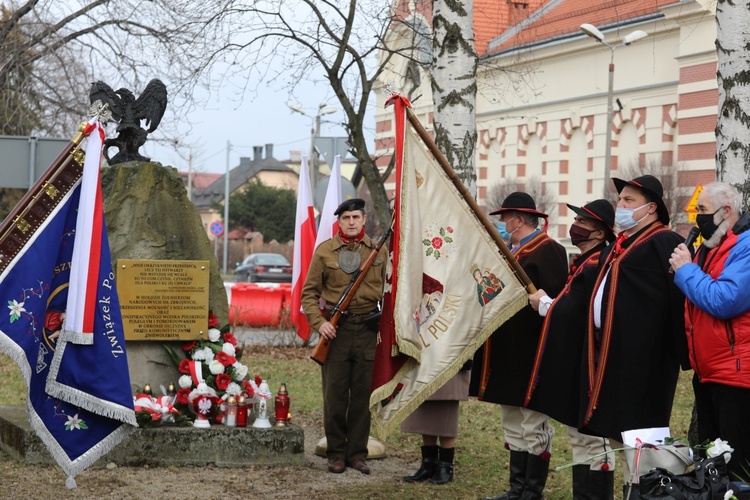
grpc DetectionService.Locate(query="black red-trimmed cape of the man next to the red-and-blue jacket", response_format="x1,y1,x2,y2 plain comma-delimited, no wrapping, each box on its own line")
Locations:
579,222,690,441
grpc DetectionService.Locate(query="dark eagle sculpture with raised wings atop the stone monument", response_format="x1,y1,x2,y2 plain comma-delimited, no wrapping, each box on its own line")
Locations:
89,78,167,165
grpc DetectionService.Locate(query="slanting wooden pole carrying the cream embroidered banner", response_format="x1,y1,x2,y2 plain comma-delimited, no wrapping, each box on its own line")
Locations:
405,106,537,294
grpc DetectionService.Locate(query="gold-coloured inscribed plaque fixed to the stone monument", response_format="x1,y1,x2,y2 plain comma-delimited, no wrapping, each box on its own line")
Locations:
117,259,209,341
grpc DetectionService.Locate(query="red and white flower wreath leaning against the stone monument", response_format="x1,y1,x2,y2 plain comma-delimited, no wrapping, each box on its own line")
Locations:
164,313,259,423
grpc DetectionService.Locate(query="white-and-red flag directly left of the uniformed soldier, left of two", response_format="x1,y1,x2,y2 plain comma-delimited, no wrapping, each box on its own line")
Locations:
292,156,316,340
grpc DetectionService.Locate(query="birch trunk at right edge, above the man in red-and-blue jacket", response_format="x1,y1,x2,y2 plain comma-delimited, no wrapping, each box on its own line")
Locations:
716,0,750,208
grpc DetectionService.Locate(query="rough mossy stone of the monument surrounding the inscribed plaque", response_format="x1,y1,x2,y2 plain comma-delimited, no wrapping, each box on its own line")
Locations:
101,162,228,390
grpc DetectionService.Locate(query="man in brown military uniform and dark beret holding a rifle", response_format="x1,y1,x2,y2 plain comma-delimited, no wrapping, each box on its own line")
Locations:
302,198,388,474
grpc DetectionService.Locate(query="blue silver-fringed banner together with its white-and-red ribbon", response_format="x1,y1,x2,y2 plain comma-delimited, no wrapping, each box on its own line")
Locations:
0,120,136,487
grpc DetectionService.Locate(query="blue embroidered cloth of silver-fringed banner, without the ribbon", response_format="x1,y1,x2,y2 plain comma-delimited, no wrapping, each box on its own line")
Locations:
0,120,135,487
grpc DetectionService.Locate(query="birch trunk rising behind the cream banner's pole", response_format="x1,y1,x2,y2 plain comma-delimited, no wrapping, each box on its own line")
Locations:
432,0,477,197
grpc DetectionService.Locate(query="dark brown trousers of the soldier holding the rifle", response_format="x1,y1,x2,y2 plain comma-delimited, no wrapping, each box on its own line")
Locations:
321,317,377,463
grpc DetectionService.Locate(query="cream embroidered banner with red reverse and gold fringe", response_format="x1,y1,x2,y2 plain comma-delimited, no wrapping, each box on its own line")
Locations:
370,96,528,434
